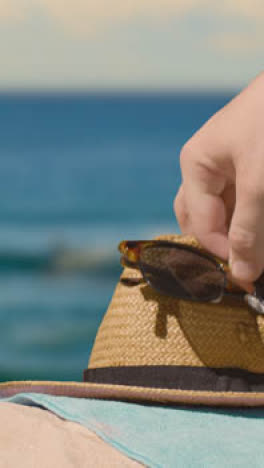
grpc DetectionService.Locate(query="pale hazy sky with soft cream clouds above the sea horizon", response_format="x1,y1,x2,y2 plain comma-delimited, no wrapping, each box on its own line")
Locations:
0,0,264,91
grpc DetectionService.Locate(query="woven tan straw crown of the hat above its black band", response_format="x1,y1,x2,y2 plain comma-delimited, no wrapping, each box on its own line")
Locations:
88,235,264,373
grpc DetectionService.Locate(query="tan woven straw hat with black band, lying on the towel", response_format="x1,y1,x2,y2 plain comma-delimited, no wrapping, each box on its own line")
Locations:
0,235,264,406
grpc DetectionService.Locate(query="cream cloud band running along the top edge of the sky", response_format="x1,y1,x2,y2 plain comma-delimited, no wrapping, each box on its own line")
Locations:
0,0,264,38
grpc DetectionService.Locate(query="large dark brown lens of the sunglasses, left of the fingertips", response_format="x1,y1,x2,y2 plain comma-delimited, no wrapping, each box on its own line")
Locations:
140,246,225,301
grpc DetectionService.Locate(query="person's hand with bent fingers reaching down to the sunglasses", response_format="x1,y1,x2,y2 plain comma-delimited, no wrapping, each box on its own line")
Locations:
174,73,264,282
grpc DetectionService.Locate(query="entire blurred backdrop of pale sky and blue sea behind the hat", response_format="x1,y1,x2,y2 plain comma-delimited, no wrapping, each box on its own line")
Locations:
0,0,264,380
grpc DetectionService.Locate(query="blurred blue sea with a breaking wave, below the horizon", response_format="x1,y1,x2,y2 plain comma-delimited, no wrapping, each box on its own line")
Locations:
0,92,234,381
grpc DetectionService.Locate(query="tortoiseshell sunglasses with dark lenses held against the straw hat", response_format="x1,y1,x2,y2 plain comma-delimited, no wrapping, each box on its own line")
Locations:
118,240,264,314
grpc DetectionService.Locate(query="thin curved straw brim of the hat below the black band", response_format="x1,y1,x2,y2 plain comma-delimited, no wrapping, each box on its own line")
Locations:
0,381,264,407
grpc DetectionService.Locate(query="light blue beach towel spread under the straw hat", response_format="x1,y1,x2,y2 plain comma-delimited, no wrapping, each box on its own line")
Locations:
0,393,264,468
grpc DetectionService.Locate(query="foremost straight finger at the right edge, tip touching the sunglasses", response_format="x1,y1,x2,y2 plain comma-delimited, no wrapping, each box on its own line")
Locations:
229,176,264,282
